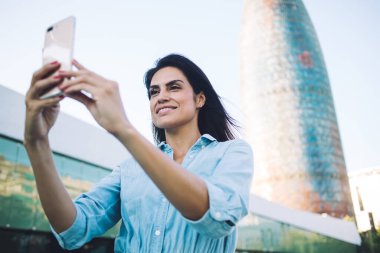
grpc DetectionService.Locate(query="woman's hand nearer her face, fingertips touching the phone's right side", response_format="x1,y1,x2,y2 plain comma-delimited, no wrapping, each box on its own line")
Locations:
59,60,129,135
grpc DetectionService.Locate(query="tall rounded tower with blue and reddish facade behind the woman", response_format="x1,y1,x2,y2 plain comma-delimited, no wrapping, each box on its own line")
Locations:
240,0,353,217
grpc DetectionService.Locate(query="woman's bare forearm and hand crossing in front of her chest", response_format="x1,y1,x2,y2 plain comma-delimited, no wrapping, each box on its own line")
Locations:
60,61,209,220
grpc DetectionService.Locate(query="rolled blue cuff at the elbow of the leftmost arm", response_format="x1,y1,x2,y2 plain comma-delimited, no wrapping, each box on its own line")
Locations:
50,206,86,250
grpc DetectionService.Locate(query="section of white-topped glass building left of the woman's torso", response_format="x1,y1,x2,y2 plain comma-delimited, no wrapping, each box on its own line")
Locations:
0,85,129,253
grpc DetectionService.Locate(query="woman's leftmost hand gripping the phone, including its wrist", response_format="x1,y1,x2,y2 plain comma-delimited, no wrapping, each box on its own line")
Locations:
24,62,63,144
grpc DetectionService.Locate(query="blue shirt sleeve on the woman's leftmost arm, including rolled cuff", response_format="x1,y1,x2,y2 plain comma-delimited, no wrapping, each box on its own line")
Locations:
51,167,121,250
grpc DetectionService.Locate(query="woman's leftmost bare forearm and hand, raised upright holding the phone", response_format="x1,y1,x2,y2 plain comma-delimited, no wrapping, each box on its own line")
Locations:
24,62,76,232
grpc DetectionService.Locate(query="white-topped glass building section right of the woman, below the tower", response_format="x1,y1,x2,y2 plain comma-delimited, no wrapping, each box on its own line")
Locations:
237,195,361,253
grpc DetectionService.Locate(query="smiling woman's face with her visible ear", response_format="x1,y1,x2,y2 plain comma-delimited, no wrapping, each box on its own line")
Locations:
149,67,205,130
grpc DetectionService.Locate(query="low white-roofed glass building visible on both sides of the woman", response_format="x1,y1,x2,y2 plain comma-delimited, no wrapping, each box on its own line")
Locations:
0,85,360,253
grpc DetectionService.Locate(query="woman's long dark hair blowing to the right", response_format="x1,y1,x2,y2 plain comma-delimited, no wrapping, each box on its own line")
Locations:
144,54,238,143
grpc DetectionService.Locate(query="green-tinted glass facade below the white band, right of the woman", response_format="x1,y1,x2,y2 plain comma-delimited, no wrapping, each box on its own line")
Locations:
236,213,358,253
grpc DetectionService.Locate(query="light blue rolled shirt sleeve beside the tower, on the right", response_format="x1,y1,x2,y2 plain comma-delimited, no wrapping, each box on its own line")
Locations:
185,140,253,238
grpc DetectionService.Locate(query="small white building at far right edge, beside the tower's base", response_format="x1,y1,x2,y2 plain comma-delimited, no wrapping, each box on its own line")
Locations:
349,167,380,232
